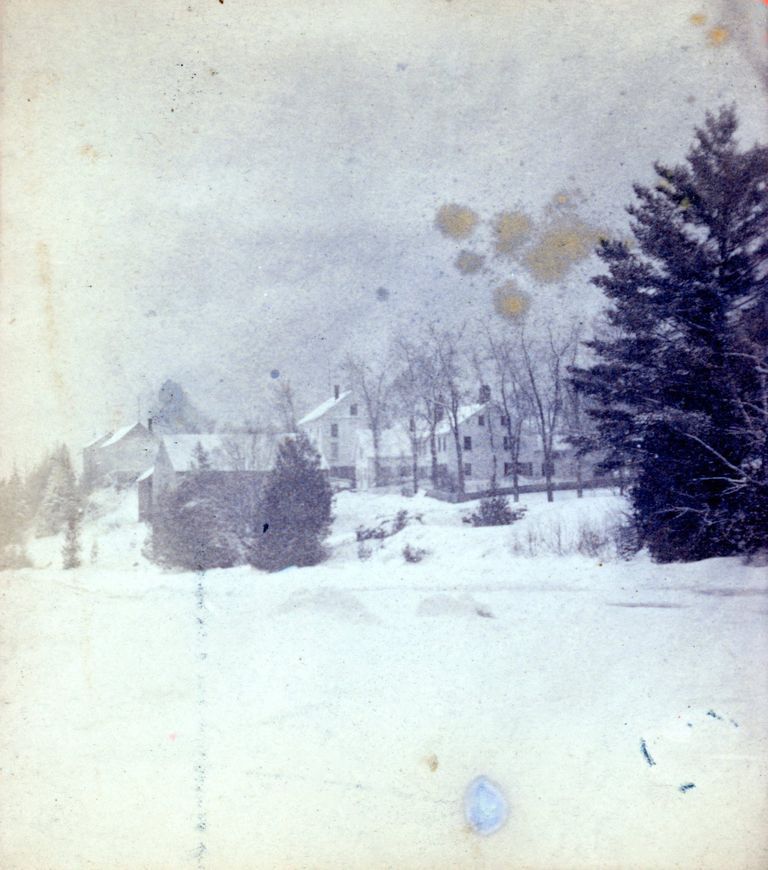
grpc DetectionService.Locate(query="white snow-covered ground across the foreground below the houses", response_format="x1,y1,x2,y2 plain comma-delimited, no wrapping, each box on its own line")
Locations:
0,492,768,870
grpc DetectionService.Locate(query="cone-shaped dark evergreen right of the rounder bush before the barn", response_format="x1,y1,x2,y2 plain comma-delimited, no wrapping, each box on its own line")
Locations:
252,434,332,571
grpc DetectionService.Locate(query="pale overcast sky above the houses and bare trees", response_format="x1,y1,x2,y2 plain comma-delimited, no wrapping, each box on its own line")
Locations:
0,0,768,468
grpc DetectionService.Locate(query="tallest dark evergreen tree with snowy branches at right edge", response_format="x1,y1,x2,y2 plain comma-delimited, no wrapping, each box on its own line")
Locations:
574,108,768,560
